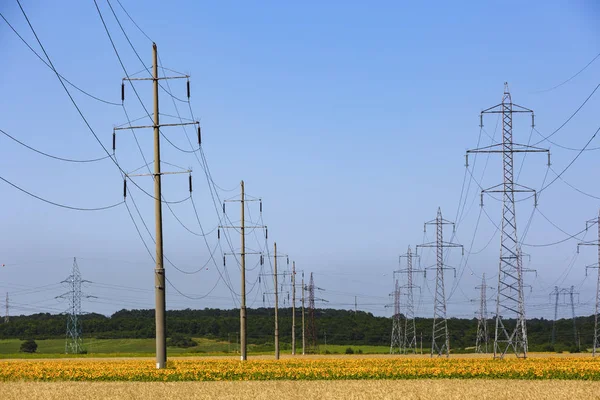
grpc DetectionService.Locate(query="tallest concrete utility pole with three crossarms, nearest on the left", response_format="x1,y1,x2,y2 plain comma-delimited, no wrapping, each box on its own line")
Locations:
113,43,200,369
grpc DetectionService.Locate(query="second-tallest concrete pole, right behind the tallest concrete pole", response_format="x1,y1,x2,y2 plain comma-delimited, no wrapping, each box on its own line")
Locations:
217,181,268,361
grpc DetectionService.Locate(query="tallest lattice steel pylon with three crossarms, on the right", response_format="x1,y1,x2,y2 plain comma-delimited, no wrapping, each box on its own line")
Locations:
466,83,550,358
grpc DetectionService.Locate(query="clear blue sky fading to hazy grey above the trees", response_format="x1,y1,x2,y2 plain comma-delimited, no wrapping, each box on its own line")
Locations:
0,0,600,317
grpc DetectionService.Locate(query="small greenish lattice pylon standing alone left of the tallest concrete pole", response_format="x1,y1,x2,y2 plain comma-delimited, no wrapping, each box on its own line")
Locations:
57,258,94,354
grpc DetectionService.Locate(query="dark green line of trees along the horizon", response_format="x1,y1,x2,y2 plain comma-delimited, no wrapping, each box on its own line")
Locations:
0,308,594,351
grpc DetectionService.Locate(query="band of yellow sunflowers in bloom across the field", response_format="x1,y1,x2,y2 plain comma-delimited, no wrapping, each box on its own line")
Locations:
0,357,600,382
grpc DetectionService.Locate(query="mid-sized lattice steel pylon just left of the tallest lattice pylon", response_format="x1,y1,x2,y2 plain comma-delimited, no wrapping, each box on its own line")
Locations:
417,208,464,357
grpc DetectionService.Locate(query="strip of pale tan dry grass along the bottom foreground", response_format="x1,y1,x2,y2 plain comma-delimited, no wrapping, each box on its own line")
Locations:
1,379,600,400
